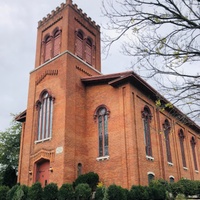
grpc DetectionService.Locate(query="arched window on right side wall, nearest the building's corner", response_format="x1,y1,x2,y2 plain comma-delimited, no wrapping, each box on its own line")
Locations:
142,106,152,157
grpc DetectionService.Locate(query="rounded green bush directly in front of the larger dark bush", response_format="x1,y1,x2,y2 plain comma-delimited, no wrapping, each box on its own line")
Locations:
75,183,92,200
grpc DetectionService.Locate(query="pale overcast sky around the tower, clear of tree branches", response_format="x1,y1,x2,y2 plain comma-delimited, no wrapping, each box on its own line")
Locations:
0,0,133,131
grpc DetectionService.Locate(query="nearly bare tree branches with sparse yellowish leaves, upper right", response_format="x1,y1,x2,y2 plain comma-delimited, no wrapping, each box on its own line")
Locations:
103,0,200,122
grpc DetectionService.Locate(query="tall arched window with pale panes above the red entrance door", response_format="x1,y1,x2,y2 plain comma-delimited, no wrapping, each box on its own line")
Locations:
37,90,53,141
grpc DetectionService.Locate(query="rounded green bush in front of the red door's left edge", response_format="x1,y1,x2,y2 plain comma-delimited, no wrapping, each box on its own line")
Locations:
28,182,43,200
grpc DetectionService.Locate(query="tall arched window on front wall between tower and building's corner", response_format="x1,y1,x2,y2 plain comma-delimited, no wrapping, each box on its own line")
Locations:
95,106,109,157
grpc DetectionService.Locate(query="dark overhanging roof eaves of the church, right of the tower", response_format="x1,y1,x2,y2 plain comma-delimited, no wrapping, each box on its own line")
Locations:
81,71,200,134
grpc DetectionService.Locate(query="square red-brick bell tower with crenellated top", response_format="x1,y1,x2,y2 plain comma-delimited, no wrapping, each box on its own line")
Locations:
18,0,101,186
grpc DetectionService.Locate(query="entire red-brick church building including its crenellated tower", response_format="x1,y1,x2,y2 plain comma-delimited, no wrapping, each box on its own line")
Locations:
16,0,200,188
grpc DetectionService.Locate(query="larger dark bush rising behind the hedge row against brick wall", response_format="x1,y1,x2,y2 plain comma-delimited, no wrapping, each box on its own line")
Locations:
74,172,99,191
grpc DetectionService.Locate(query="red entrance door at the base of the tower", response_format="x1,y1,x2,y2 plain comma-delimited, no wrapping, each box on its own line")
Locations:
36,160,50,187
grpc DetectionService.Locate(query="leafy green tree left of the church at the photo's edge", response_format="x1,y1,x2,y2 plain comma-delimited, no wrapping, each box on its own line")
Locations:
0,116,21,187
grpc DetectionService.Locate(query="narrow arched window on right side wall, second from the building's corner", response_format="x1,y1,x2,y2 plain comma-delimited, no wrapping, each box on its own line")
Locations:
163,119,172,163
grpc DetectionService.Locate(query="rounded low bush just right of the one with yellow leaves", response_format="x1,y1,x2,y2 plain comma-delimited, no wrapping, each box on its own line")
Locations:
108,184,127,200
